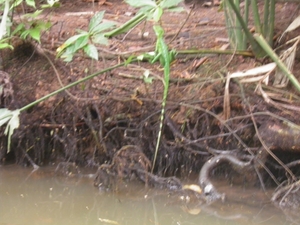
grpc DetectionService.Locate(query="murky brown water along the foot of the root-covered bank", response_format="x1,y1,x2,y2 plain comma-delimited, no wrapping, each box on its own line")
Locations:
0,166,296,225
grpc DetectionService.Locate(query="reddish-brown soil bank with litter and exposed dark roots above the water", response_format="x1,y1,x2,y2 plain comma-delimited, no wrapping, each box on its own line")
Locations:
0,0,300,192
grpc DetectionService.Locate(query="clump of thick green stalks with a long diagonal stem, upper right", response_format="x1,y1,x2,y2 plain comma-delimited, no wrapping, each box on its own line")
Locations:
223,0,300,91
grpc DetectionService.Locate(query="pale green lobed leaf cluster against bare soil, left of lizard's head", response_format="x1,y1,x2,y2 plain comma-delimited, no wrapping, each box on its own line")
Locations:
57,11,115,62
